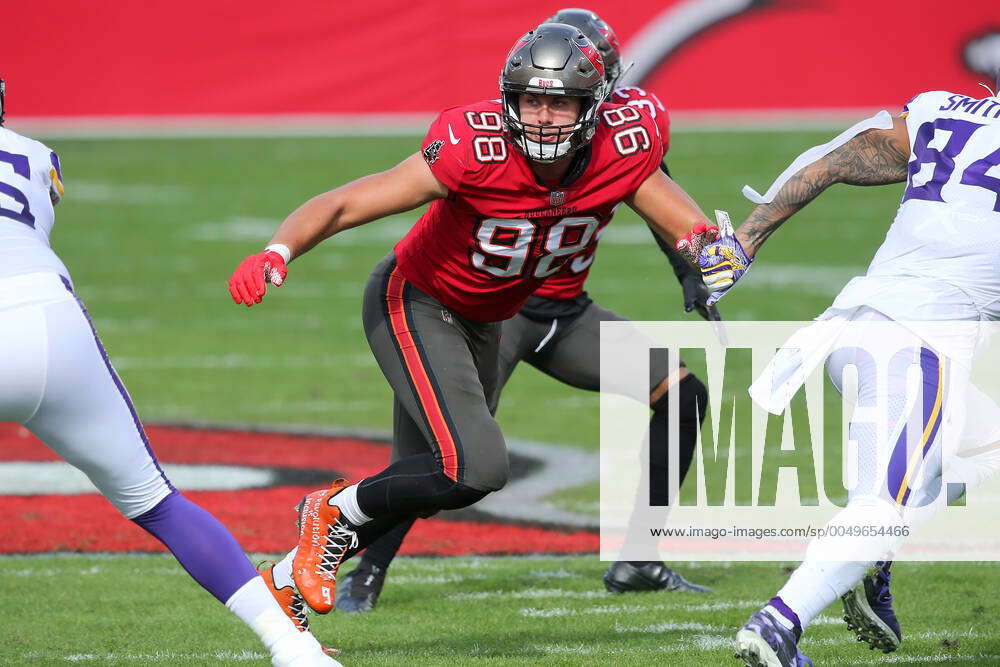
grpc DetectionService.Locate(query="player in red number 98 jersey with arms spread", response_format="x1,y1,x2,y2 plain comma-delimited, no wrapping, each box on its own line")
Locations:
229,24,708,636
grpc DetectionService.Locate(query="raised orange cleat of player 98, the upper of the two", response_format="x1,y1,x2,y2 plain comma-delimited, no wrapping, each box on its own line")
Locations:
292,479,358,614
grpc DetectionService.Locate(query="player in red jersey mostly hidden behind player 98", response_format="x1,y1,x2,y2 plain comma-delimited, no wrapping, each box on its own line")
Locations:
335,9,719,613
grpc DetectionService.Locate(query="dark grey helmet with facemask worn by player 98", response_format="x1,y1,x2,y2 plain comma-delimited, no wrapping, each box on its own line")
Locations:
500,24,605,163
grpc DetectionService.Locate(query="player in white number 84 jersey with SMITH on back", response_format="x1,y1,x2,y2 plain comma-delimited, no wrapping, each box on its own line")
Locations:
679,75,1000,666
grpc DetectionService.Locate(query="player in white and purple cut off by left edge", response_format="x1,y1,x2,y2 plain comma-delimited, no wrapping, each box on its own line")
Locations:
0,79,339,667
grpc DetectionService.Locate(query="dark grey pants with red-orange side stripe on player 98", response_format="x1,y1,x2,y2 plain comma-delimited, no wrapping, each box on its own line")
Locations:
363,254,508,492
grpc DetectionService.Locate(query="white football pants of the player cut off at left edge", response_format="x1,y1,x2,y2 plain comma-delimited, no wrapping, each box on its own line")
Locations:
0,273,172,519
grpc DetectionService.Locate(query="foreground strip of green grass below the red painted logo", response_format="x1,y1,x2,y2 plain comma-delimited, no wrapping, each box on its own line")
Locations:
7,556,1000,665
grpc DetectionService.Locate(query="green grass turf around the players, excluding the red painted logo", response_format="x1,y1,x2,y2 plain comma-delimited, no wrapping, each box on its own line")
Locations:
0,127,1000,665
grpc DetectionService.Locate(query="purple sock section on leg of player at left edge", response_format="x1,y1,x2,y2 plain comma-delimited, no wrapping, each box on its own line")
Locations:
133,491,257,604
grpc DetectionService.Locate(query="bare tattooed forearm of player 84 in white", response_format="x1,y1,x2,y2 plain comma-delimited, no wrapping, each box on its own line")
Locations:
736,118,910,257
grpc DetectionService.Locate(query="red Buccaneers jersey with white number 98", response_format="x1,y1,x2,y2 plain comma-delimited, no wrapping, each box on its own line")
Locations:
396,100,663,322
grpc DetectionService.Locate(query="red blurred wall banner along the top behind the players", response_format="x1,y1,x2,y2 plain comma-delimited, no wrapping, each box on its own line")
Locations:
0,0,1000,118
